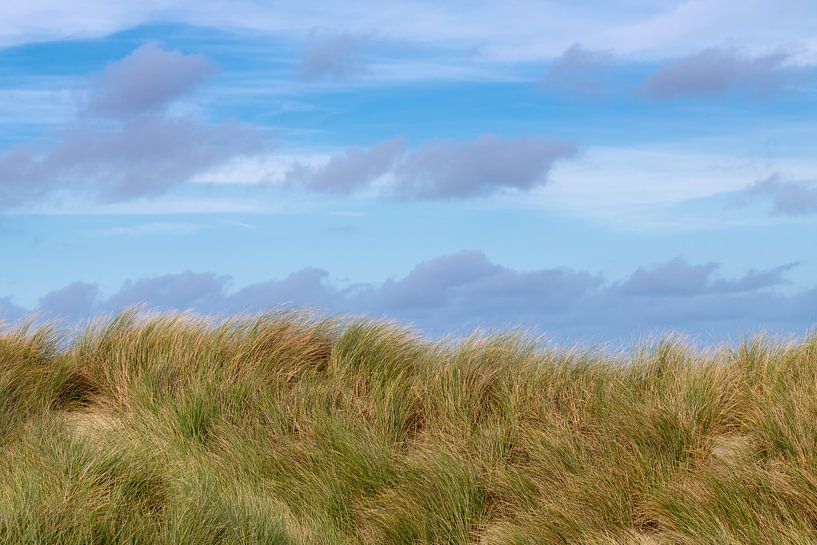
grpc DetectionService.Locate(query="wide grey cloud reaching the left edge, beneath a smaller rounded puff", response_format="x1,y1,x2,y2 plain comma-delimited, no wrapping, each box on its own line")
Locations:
0,114,266,207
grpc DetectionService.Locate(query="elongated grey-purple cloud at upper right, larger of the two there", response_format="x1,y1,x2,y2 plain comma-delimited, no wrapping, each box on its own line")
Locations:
643,48,795,100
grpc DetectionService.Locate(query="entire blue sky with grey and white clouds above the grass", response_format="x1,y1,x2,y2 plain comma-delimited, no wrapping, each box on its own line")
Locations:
0,0,817,345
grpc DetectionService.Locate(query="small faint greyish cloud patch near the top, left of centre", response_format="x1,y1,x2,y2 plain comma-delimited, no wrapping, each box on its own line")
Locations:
298,32,371,80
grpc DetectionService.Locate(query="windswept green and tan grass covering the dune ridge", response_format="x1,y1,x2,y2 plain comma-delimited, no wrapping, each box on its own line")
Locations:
0,314,817,545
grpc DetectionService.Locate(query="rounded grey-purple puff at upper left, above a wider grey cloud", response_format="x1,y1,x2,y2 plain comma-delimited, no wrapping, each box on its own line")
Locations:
86,43,214,117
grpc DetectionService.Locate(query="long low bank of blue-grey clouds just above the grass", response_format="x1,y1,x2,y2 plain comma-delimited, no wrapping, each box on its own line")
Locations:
7,251,817,341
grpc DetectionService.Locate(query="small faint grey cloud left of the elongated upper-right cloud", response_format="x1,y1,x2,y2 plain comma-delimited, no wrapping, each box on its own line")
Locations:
542,43,613,94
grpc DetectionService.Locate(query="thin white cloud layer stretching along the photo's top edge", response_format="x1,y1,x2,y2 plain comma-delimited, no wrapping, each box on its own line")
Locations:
0,0,817,62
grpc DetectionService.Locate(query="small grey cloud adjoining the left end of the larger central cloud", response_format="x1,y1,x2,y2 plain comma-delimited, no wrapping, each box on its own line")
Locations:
286,138,405,195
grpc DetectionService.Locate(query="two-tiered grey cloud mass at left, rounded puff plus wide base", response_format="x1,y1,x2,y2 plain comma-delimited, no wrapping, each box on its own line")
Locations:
0,44,269,209
